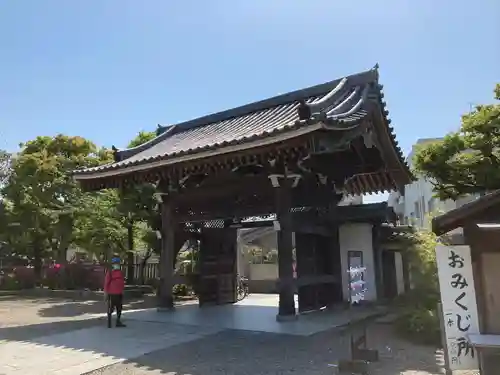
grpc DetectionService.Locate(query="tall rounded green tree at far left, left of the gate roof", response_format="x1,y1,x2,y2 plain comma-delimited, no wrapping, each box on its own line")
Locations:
2,134,112,277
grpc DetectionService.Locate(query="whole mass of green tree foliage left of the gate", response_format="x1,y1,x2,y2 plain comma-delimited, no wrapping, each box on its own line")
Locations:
0,131,176,286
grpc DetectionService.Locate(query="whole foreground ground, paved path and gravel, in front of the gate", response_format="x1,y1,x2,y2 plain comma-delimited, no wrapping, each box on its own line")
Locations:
0,296,474,375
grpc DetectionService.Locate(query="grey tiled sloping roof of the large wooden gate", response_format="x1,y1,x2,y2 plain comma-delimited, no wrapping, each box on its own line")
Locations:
75,66,406,180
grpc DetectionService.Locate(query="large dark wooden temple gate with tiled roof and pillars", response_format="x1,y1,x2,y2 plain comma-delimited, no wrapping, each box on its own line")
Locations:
75,66,412,319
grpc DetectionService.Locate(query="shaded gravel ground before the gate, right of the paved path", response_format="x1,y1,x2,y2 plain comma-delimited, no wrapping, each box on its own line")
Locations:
82,326,441,375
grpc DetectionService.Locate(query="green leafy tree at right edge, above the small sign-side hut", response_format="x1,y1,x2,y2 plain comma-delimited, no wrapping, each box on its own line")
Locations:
413,84,500,200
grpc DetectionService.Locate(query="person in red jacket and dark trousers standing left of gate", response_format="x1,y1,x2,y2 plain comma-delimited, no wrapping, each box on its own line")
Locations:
104,256,126,328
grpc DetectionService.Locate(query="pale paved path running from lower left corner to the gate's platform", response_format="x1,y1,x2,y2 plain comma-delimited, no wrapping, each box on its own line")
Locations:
0,321,222,375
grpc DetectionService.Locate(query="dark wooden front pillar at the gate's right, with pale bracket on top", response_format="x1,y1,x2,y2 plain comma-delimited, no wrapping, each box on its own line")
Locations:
270,174,296,321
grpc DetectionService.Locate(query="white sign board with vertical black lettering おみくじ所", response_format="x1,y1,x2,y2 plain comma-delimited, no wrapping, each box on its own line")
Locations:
436,245,479,371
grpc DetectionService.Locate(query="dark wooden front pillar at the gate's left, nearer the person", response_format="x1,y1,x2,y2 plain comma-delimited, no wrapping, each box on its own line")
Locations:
158,195,176,311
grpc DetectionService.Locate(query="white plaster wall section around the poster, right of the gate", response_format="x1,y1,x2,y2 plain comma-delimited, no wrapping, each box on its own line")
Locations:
339,223,377,301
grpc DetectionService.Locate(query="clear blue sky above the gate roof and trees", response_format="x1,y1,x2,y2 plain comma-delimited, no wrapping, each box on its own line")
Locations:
0,0,500,203
